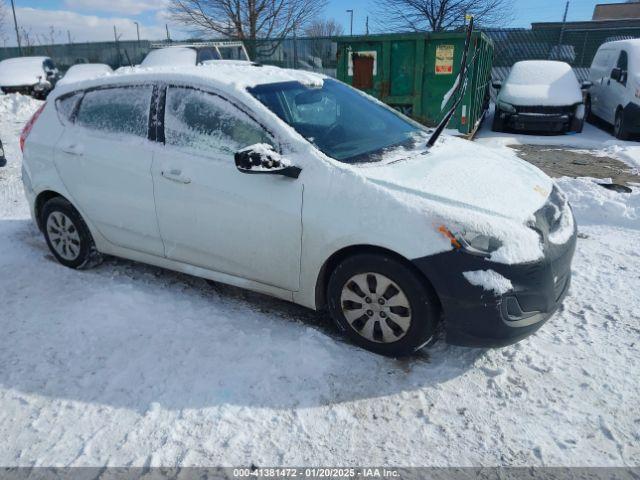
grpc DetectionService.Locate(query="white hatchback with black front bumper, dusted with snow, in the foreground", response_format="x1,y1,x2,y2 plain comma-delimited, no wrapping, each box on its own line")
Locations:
21,62,576,355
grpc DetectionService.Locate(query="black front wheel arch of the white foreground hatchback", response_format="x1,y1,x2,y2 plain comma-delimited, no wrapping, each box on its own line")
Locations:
315,244,442,312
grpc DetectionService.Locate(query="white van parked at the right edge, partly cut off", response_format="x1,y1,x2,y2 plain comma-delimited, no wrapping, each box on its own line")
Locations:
586,39,640,140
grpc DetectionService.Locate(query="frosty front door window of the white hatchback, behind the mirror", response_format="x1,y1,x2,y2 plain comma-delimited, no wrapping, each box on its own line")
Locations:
164,87,273,157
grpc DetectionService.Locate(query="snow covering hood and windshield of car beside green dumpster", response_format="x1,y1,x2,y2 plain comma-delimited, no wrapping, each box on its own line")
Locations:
498,60,582,106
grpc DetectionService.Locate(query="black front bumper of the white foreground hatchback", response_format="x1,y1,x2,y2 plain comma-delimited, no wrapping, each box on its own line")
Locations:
414,223,577,347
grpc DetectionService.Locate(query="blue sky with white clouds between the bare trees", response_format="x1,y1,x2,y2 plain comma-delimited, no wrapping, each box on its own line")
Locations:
0,0,632,46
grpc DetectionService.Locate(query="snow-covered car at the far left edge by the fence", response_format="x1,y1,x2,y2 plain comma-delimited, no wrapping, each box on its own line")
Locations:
0,57,60,98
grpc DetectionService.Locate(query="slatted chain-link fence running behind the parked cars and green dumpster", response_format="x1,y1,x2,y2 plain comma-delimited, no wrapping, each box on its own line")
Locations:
0,24,640,79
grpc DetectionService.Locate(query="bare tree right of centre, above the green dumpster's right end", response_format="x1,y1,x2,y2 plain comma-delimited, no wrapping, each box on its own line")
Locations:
376,0,512,32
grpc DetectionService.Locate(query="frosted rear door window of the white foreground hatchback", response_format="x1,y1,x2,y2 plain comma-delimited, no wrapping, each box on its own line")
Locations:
76,85,153,138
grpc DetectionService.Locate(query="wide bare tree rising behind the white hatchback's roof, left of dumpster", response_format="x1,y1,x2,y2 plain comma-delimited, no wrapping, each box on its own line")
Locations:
169,0,327,46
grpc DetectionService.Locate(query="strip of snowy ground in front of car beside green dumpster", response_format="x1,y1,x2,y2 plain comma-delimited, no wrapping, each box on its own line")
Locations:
476,106,640,170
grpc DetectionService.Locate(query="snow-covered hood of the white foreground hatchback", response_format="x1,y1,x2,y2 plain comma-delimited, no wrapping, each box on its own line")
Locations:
361,137,553,223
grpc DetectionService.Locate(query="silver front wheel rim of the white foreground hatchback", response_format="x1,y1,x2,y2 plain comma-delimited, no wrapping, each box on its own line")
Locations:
340,272,411,343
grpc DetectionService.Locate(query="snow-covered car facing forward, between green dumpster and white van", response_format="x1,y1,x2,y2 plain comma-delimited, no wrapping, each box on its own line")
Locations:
492,60,590,133
